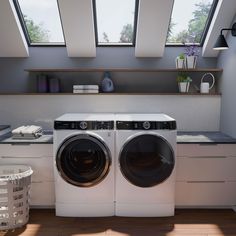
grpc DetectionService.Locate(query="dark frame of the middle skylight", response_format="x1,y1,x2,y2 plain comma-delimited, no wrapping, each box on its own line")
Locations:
93,0,139,47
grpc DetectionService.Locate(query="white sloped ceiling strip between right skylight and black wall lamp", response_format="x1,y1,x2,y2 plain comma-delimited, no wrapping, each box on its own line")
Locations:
202,0,236,57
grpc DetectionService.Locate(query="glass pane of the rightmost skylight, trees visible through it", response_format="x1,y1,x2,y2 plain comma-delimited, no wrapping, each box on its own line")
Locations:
167,0,217,45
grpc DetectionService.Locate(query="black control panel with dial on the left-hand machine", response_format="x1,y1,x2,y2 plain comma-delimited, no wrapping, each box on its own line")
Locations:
54,120,114,130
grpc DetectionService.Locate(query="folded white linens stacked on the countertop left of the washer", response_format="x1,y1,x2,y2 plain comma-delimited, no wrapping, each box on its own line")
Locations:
12,125,43,139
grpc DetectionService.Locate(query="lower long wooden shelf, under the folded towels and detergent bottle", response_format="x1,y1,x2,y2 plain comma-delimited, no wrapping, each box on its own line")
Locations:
0,93,221,96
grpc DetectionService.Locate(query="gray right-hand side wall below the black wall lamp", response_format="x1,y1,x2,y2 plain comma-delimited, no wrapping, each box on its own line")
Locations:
217,15,236,138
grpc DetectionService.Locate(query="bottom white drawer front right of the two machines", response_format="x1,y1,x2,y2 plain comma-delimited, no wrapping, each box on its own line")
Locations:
175,181,236,207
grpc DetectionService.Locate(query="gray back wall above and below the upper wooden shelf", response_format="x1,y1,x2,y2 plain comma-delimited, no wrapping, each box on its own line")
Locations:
0,47,217,93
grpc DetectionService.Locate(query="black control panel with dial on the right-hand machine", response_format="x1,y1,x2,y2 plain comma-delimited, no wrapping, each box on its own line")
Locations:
116,121,176,130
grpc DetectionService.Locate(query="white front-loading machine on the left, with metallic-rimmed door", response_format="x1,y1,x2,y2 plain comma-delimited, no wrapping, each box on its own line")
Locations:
53,114,114,217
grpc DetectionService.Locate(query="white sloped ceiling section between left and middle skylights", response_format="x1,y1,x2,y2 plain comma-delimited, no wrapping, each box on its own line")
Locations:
58,0,96,57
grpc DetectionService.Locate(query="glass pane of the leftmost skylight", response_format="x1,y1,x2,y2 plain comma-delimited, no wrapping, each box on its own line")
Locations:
16,0,64,45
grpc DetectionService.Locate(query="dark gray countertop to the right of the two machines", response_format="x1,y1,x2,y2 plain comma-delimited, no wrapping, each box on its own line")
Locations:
177,132,236,144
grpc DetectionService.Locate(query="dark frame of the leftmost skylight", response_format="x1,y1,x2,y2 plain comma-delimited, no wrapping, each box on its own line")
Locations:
13,0,66,47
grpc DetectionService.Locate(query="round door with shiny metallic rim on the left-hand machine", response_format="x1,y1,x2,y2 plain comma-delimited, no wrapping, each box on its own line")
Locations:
56,134,111,187
